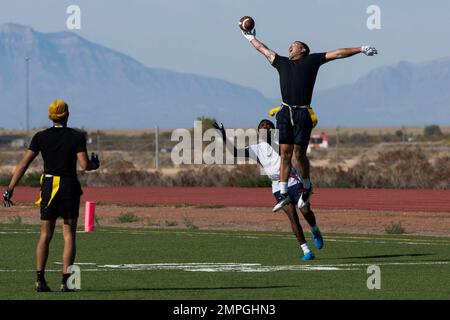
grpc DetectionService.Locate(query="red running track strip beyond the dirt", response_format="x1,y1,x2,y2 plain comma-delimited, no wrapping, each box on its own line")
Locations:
13,187,450,212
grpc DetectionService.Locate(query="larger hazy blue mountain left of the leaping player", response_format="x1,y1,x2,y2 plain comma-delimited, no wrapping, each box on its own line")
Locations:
0,23,271,128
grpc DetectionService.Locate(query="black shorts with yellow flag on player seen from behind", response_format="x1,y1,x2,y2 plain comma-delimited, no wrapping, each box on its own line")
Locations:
39,177,83,220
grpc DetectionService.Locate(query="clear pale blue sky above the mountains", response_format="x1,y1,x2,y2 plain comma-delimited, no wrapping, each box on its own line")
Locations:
0,0,450,98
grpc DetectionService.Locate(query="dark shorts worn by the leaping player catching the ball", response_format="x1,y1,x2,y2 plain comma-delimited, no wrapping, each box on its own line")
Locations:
276,106,313,147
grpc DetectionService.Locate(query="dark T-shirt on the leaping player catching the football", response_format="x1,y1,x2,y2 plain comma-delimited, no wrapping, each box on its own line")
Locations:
272,52,327,106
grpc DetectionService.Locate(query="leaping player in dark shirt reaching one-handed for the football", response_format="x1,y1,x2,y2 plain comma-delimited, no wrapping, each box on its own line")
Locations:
242,30,378,211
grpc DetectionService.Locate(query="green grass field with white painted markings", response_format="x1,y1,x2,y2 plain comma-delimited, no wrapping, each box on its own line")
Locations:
0,222,450,300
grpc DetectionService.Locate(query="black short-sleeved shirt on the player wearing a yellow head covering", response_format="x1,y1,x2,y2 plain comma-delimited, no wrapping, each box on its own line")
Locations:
28,127,86,177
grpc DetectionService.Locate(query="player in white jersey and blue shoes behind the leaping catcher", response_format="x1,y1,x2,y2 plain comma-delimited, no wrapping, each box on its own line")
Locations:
214,119,323,261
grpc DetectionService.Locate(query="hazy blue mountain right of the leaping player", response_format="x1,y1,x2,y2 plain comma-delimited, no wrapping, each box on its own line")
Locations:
314,57,450,127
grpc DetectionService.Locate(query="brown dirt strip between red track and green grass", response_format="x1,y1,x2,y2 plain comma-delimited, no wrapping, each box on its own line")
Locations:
0,204,450,236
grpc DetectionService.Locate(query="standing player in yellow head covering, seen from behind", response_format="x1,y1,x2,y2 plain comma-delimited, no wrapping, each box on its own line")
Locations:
3,99,100,292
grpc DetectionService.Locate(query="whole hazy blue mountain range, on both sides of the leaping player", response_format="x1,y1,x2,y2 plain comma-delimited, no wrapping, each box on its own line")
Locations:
0,23,450,128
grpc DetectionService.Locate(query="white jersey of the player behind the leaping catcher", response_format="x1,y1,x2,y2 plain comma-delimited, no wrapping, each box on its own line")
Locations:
248,142,302,193
